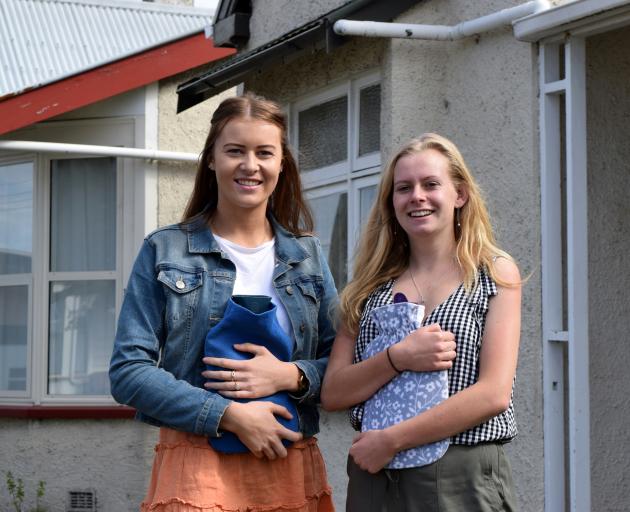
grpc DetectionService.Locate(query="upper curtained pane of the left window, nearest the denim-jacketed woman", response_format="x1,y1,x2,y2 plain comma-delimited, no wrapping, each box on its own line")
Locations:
50,158,116,272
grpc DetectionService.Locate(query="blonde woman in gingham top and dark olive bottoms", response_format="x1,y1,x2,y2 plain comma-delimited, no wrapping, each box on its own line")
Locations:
322,133,521,512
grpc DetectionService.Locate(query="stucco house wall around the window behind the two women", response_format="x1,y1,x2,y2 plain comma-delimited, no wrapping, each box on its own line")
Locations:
246,0,544,512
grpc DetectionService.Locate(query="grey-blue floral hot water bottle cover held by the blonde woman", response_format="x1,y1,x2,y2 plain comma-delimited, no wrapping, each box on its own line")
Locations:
361,294,449,469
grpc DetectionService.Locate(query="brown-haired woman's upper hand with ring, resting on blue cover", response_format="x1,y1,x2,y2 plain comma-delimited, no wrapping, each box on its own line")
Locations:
201,343,299,399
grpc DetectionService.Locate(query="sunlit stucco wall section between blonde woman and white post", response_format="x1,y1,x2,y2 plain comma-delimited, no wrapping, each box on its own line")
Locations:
382,9,544,512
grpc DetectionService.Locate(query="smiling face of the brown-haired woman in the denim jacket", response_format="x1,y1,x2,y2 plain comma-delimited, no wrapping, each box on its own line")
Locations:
210,117,282,215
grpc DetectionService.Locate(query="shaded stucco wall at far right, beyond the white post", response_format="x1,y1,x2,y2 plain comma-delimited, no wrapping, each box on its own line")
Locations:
586,28,630,512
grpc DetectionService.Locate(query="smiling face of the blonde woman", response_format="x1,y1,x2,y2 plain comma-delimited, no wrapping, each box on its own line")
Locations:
392,149,466,239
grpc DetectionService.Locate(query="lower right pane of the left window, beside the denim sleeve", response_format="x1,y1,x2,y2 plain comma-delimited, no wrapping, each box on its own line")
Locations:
48,281,115,395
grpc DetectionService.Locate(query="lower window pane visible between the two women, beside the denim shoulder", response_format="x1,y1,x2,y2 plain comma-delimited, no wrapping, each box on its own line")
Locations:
310,192,348,290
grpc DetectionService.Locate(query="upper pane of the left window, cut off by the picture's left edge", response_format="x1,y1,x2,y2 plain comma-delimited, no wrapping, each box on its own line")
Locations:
0,162,33,274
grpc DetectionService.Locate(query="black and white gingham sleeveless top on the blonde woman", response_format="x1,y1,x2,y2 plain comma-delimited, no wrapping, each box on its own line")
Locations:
350,270,517,445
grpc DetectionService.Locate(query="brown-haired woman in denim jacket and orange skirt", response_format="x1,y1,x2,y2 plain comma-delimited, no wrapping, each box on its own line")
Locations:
110,94,336,512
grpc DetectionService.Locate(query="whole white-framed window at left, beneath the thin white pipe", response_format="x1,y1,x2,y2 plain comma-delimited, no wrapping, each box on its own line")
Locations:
0,118,141,405
